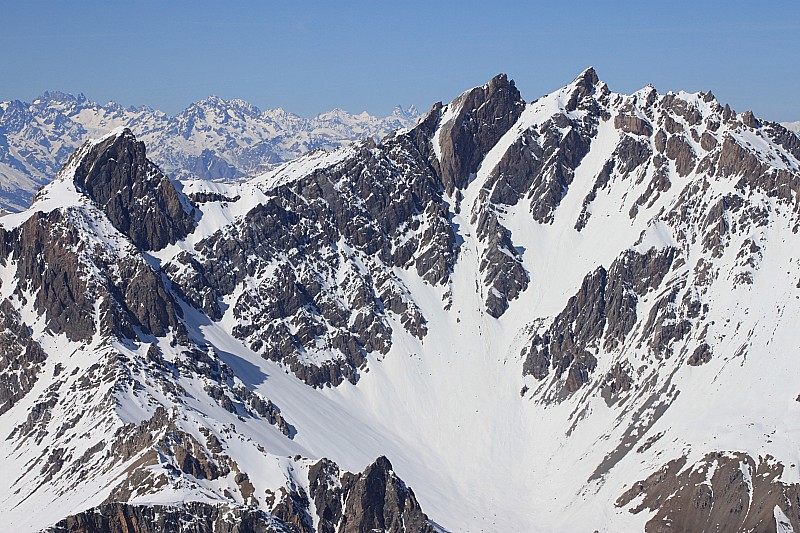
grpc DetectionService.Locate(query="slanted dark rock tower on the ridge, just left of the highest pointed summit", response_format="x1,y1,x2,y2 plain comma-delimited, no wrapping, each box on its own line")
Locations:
439,74,525,194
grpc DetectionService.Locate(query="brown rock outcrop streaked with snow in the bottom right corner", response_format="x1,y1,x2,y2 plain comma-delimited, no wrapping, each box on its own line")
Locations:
616,453,800,533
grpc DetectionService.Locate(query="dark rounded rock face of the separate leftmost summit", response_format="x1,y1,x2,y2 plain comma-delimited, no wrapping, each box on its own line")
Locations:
72,129,194,250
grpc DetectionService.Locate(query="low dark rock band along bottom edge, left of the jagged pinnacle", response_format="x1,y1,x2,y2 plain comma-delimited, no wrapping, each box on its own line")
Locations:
45,502,291,533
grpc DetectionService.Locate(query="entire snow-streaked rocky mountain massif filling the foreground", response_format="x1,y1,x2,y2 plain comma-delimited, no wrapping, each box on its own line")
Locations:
0,69,800,533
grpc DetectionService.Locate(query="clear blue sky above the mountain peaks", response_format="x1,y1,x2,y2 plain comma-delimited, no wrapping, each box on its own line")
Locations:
0,0,800,120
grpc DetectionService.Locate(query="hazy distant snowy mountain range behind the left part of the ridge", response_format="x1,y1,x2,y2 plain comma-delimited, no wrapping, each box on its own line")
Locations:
0,91,418,211
